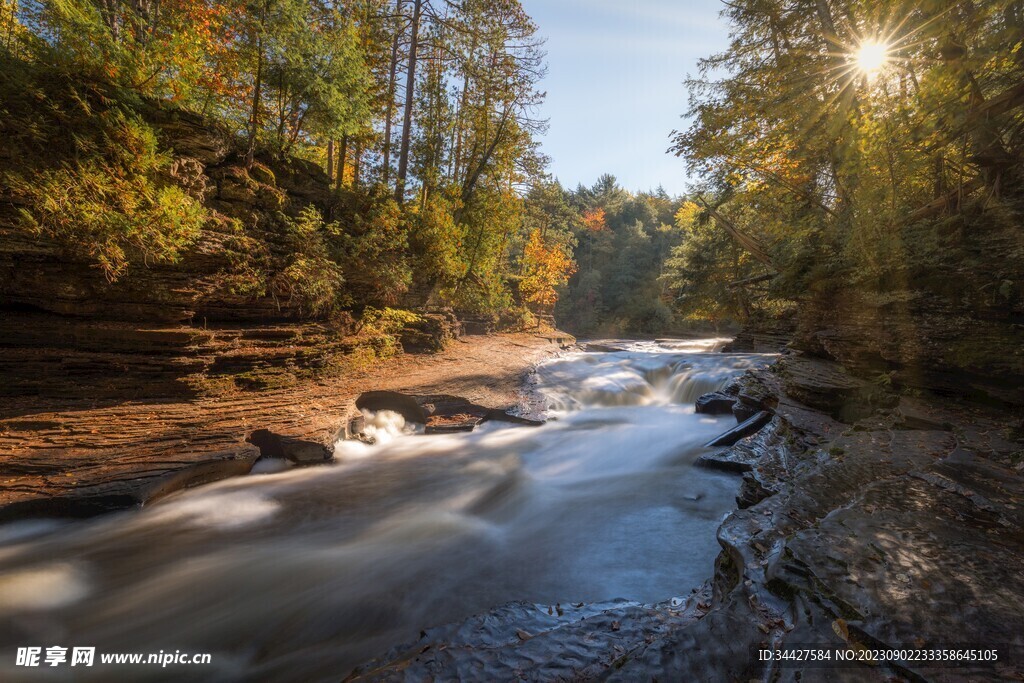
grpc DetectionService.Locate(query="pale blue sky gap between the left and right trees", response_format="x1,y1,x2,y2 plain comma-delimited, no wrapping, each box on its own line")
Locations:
522,0,727,195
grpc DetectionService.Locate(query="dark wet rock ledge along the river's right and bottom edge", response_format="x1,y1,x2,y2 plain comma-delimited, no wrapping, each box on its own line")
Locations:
350,354,1024,681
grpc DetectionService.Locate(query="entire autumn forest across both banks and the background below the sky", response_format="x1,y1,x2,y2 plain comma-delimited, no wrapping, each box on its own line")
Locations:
0,0,1024,334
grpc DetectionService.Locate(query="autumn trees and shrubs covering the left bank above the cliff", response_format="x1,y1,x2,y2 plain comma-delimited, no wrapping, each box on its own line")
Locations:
0,0,572,325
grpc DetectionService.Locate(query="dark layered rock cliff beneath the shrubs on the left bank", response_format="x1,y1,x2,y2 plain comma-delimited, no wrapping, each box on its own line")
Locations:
0,98,460,399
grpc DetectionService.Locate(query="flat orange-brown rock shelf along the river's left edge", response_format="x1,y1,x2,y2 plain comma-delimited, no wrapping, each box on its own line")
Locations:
0,334,570,519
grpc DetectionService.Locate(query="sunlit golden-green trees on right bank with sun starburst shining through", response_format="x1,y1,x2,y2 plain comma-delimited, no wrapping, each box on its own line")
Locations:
674,0,1024,305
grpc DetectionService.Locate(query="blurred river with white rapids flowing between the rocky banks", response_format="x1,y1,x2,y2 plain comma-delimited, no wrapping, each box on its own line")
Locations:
0,340,763,681
